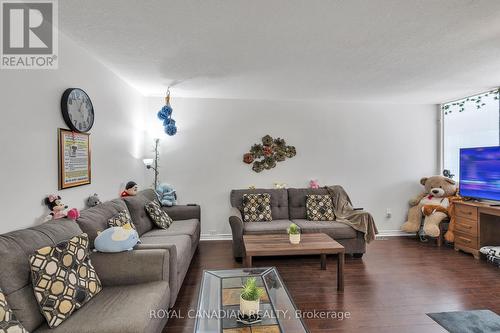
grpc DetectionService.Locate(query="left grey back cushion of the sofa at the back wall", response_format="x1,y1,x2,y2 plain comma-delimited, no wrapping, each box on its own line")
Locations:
231,189,288,220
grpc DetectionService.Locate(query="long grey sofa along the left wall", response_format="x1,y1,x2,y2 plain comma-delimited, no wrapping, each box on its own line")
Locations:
0,190,200,333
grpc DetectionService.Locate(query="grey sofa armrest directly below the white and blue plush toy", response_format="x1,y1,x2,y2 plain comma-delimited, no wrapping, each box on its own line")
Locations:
90,249,170,286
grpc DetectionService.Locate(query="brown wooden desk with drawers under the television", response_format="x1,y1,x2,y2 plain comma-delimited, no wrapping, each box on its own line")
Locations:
455,201,500,259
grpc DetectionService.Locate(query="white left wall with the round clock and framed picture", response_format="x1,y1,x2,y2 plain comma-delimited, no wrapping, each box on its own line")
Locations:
0,35,145,233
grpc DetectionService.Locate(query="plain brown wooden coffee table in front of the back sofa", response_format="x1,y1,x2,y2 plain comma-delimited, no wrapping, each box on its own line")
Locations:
243,232,345,291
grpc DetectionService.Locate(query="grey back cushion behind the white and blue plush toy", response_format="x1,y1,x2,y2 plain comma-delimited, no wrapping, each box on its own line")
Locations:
76,199,128,249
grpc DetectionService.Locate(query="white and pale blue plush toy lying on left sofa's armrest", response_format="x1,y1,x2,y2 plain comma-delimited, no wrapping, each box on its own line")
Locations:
94,223,139,252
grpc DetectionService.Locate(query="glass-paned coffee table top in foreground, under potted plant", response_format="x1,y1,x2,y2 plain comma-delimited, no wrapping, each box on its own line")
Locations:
194,267,308,333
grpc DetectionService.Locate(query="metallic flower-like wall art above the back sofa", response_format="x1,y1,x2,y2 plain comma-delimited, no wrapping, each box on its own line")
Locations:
243,135,297,173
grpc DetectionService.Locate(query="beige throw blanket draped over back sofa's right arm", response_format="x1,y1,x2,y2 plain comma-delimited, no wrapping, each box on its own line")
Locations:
326,185,378,243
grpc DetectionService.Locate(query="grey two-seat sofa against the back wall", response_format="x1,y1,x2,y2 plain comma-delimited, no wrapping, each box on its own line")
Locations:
229,188,366,260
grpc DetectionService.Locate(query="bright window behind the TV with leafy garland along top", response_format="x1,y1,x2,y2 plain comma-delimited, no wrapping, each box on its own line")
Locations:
441,90,500,179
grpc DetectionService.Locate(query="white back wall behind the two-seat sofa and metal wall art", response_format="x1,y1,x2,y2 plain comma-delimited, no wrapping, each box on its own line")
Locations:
146,96,439,235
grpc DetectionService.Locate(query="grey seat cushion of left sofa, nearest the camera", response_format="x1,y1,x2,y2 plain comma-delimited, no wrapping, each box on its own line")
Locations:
33,281,170,333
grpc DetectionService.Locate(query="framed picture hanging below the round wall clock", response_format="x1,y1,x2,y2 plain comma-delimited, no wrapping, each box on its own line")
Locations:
58,128,91,190
